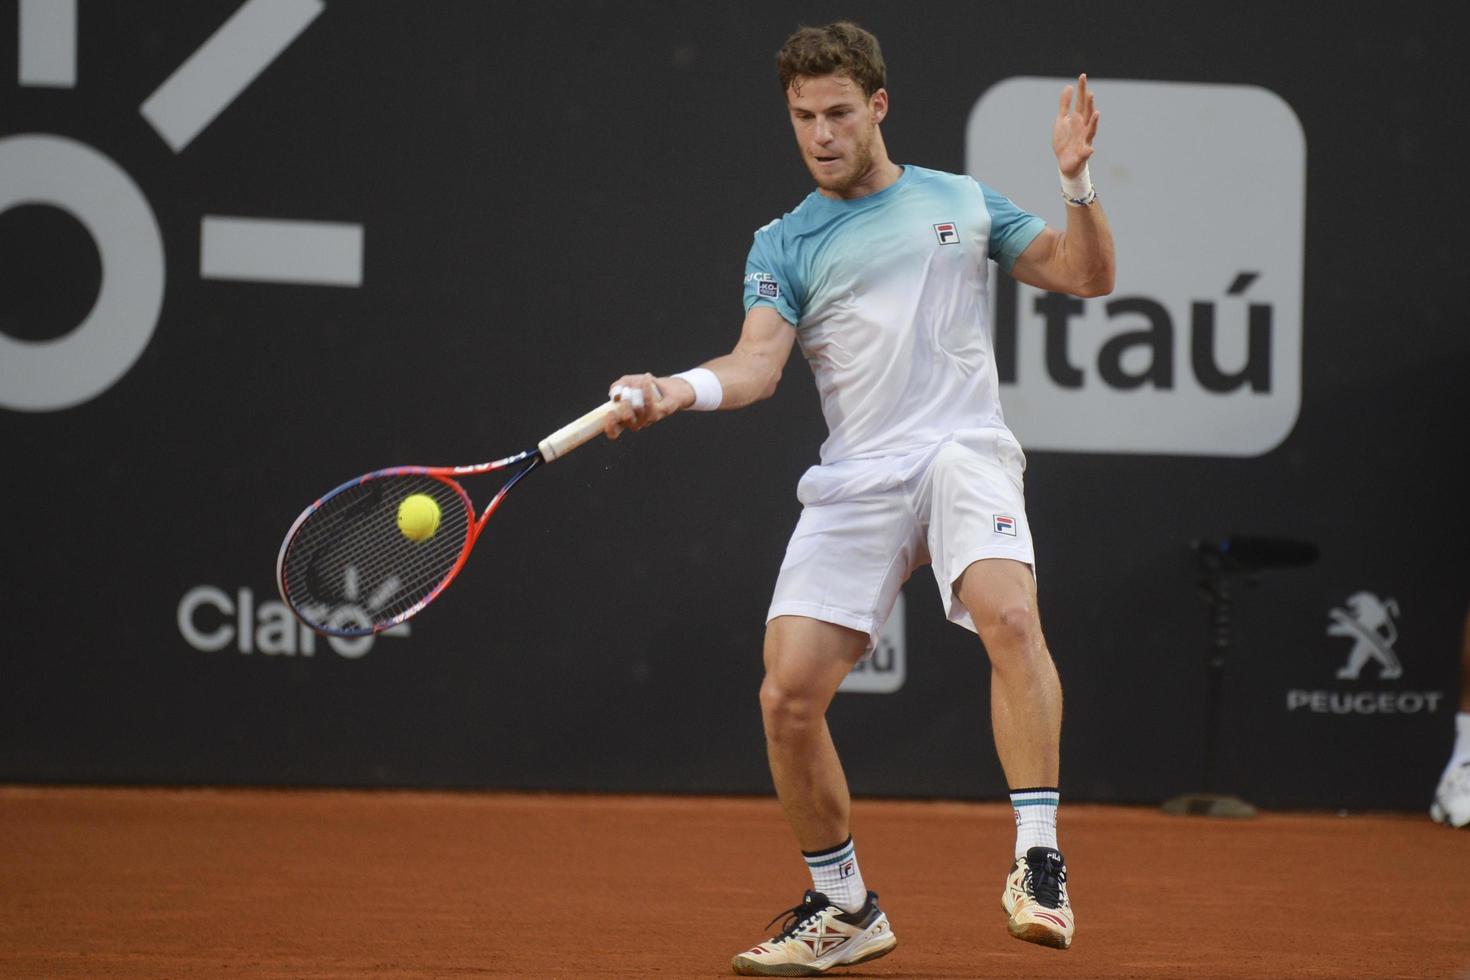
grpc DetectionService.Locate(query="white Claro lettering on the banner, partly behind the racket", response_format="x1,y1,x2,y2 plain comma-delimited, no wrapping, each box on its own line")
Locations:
178,585,409,660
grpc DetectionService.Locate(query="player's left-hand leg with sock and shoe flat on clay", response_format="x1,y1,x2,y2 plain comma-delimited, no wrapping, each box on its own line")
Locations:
731,616,897,976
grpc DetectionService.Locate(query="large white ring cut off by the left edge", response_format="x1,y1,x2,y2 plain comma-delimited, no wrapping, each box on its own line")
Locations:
0,134,163,411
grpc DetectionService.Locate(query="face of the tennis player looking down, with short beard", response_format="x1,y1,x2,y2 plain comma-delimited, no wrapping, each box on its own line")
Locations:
786,75,888,197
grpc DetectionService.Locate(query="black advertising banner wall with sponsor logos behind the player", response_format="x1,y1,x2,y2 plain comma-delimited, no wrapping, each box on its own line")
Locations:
0,0,1470,810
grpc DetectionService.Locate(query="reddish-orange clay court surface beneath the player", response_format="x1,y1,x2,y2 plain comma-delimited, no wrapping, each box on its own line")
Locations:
0,786,1470,980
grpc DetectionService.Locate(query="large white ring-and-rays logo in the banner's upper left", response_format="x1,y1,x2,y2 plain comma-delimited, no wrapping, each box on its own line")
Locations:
0,0,363,411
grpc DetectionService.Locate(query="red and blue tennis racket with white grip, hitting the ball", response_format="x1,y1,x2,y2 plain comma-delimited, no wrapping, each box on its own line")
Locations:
276,401,614,636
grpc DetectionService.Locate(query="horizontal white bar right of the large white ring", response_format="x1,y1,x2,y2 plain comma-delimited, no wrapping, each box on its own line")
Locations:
198,215,363,287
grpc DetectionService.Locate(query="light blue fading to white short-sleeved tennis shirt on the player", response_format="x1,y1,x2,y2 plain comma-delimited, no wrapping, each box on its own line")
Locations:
745,166,1045,464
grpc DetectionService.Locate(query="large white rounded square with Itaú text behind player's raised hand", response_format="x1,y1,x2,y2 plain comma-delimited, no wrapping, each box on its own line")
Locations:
966,78,1307,455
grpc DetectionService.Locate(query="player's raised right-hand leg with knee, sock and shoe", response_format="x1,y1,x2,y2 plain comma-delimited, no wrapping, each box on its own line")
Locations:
956,558,1076,949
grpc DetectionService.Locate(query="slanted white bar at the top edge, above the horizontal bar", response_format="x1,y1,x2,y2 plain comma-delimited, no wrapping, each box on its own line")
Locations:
141,0,323,153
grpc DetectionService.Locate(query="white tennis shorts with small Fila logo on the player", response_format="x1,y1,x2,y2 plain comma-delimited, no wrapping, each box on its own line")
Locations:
766,429,1036,651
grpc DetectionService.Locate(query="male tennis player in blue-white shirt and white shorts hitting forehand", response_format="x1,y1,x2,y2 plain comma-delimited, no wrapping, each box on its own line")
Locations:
607,22,1113,976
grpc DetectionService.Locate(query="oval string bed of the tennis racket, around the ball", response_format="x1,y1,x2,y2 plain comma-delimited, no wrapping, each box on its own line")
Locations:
282,473,475,633
